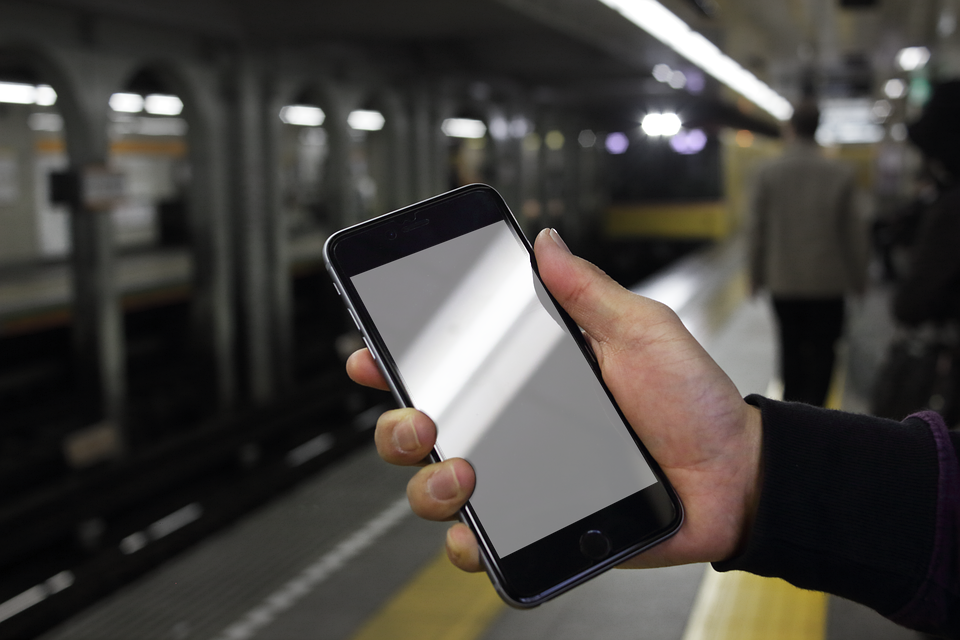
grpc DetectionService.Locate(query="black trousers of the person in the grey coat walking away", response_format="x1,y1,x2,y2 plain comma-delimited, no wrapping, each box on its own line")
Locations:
773,297,843,407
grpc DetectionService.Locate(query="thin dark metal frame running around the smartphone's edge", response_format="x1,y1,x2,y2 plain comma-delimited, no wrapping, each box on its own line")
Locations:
323,184,684,609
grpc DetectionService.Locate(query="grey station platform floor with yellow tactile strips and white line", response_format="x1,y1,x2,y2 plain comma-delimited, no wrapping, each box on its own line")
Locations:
37,242,918,640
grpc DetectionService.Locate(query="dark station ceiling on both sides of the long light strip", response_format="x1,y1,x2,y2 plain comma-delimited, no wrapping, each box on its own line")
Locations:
26,0,942,129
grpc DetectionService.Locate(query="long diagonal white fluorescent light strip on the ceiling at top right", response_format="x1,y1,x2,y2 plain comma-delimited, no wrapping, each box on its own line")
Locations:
600,0,793,120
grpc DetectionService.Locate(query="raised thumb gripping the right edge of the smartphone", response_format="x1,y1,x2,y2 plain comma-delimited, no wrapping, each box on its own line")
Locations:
534,229,659,343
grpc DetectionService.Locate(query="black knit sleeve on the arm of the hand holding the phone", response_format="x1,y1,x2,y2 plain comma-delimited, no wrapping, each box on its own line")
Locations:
714,396,960,637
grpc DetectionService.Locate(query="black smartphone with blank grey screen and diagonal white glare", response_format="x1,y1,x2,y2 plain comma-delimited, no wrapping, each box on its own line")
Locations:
324,185,683,608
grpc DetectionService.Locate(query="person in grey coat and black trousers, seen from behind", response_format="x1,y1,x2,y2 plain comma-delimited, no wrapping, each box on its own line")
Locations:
749,103,866,406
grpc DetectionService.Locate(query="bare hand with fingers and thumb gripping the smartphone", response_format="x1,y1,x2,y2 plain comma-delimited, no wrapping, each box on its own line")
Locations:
347,230,761,571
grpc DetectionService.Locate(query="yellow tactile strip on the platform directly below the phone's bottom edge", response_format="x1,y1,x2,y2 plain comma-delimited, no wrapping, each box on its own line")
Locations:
352,553,506,640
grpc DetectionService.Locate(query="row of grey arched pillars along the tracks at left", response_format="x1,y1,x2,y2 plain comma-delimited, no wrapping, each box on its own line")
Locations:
0,2,612,444
